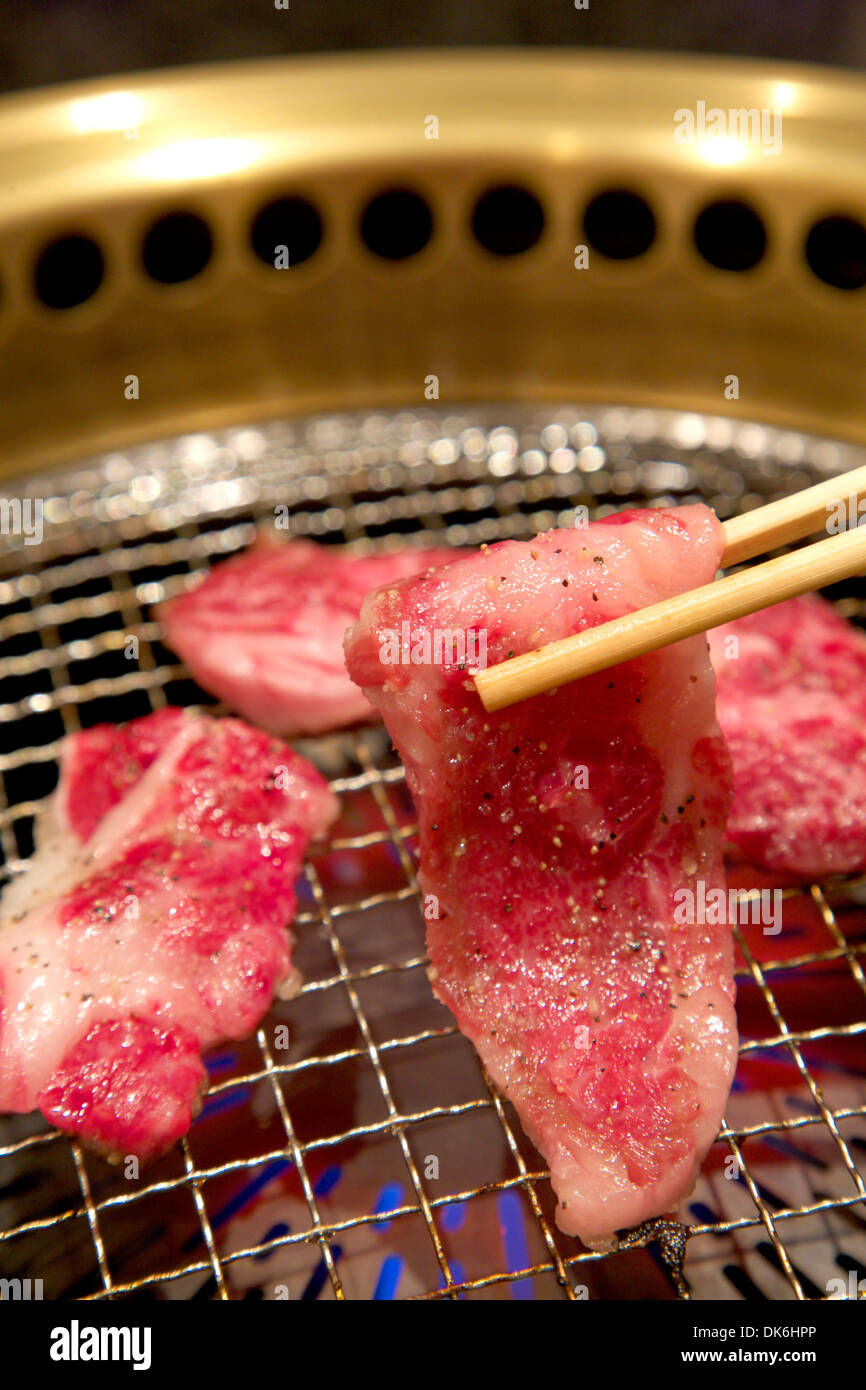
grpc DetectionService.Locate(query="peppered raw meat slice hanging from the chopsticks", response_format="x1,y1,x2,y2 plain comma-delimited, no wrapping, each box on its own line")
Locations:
346,506,737,1244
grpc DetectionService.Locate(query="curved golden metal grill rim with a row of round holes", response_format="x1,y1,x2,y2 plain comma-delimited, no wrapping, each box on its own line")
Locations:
0,49,866,475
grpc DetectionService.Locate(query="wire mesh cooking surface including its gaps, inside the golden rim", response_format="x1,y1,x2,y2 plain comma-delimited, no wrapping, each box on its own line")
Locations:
0,407,866,1300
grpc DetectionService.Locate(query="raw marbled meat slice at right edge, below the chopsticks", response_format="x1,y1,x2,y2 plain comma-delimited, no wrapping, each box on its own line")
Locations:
709,594,866,878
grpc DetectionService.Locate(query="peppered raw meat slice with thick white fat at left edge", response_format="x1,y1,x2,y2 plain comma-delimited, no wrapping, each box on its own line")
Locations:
0,709,336,1159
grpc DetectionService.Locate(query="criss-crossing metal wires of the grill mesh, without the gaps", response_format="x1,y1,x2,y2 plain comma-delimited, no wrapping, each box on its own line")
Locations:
0,406,866,1300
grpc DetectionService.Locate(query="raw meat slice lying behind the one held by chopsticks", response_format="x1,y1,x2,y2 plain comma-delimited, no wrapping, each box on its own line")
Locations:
157,539,456,735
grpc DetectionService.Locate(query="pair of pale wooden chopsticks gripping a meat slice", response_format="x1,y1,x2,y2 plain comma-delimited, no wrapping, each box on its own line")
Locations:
473,467,866,712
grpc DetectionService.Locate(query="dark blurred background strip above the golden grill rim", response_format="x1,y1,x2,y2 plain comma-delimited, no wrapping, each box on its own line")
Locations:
0,0,866,92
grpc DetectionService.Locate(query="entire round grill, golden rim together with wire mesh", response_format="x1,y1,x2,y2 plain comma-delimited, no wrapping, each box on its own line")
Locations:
0,54,866,1298
